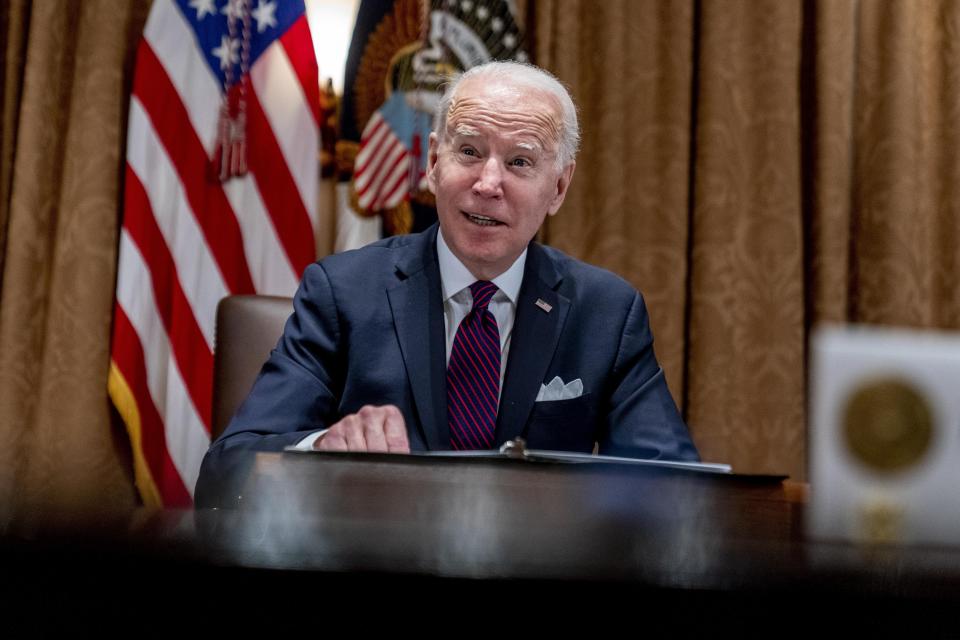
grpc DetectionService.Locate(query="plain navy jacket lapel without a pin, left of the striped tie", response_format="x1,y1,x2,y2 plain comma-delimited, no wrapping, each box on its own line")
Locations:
387,226,450,451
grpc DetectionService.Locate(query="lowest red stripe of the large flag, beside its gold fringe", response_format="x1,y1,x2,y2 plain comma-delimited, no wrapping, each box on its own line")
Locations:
113,305,193,507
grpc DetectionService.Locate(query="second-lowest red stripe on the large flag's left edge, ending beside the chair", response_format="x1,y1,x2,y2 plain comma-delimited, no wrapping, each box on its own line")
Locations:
124,165,213,433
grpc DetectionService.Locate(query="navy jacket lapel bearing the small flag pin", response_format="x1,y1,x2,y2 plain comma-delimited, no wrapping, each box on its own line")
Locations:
496,244,570,447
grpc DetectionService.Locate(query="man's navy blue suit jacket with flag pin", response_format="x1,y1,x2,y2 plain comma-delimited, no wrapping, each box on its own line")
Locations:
196,225,698,505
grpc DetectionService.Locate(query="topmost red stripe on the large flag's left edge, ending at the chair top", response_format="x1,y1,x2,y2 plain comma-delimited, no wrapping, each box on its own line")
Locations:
133,40,254,294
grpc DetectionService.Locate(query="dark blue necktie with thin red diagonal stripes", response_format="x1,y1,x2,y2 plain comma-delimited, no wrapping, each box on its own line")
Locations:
447,280,500,450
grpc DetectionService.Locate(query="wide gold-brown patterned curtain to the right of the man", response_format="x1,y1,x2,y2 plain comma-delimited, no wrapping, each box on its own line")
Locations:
533,0,960,478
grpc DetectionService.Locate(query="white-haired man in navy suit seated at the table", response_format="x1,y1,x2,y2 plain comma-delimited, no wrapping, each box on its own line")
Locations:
197,62,698,504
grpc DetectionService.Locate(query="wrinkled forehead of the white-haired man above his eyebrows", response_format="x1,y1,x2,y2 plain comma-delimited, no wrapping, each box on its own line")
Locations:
447,76,562,147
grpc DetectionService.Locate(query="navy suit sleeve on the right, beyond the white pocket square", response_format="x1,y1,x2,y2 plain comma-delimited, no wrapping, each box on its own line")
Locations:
599,293,700,462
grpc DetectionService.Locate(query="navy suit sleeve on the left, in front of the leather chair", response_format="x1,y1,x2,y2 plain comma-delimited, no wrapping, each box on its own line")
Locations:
194,264,344,507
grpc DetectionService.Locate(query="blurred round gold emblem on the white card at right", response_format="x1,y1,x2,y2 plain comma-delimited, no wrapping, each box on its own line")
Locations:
843,378,933,472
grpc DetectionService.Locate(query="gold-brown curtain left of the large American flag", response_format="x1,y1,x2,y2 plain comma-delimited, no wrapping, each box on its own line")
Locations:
0,0,147,531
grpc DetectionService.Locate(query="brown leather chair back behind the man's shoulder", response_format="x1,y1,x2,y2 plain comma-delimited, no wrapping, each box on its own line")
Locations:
211,295,293,438
